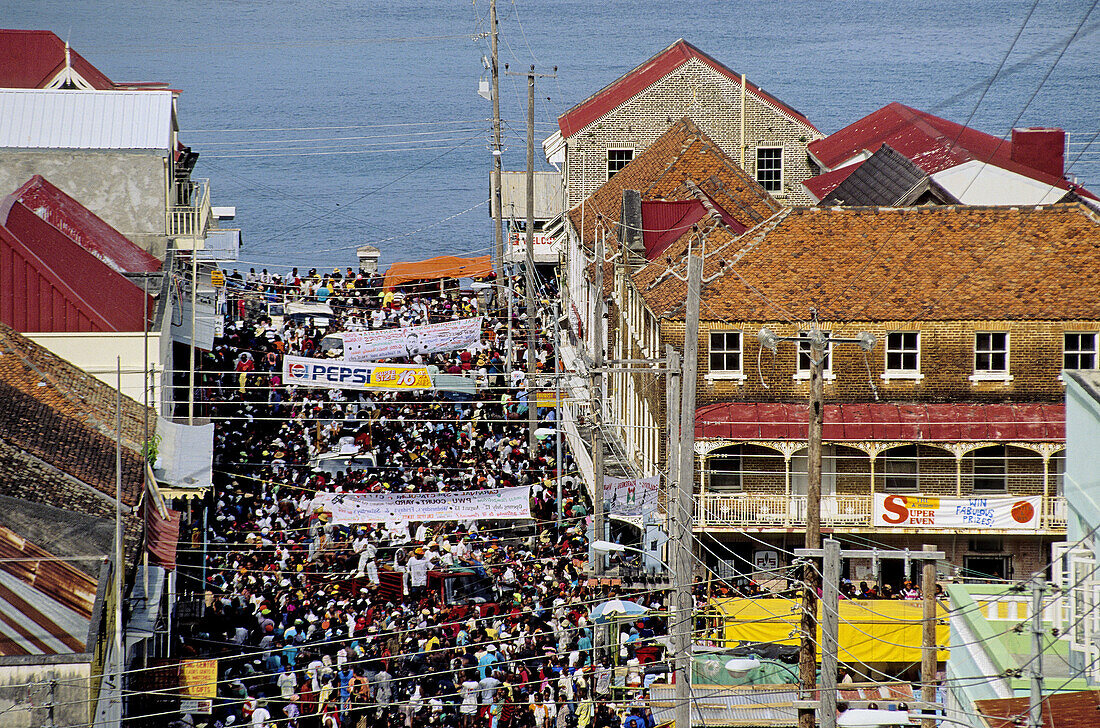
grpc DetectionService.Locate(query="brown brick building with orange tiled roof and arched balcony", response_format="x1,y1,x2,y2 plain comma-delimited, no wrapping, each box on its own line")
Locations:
606,203,1100,584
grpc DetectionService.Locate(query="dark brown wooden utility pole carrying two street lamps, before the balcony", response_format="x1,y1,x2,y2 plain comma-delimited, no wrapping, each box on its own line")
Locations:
799,323,825,728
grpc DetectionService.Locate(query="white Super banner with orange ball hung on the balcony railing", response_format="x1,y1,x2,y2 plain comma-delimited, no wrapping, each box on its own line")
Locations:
873,493,1043,531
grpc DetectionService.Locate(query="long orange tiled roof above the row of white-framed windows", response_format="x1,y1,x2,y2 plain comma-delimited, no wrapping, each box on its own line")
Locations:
634,202,1100,321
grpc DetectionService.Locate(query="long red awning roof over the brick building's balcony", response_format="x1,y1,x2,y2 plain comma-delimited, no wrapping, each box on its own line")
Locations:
695,402,1066,442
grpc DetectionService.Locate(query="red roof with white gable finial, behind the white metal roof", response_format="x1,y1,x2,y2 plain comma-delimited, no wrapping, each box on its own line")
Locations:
0,30,118,91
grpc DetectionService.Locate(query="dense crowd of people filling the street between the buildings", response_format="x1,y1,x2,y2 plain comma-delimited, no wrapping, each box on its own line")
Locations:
177,269,667,728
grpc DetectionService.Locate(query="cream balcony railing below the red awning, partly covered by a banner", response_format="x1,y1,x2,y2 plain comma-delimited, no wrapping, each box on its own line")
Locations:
695,493,1066,530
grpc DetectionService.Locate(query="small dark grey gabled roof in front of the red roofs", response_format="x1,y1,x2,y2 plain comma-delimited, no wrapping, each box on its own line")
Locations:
822,144,958,207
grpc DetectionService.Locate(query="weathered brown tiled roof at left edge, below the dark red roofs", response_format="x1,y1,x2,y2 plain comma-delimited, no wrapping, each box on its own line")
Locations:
0,324,147,515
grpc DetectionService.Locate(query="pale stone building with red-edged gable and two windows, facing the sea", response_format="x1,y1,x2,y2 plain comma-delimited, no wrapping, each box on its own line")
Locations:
542,40,823,210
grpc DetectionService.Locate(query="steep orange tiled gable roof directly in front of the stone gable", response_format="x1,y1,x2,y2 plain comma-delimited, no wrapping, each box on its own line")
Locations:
569,117,781,254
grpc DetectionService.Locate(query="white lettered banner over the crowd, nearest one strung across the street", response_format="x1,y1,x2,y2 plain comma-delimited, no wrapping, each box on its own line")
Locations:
312,485,531,523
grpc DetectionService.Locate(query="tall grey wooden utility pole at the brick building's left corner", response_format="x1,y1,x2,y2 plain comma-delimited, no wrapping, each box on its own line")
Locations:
669,250,703,728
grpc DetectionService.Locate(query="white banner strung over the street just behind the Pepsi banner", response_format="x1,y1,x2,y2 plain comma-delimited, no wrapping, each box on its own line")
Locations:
342,316,482,362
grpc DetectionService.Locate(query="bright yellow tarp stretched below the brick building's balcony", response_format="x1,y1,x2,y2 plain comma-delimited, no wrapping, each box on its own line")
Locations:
711,598,949,662
